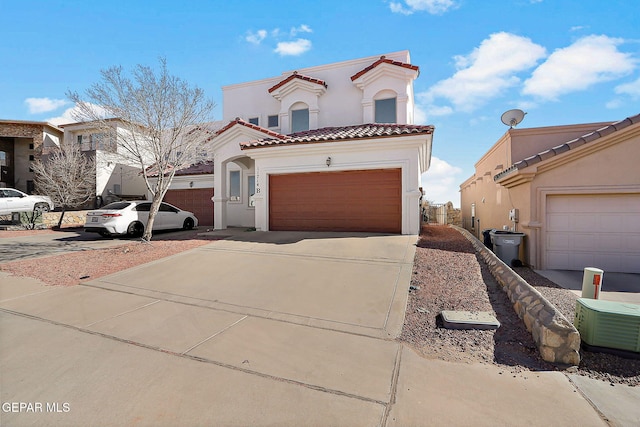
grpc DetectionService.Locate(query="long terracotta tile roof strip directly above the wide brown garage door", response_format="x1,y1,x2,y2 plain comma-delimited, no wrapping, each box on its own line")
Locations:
240,123,434,150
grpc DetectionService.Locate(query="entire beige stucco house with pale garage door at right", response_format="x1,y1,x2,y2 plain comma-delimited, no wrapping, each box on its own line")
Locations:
460,115,640,273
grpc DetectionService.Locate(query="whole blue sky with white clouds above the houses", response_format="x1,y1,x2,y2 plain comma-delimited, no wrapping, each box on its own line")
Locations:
0,0,640,206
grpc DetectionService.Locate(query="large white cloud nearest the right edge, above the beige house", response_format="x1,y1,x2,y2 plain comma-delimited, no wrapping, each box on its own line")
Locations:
522,35,637,100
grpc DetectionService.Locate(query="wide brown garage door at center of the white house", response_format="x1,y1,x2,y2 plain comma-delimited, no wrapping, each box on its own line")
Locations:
269,169,402,233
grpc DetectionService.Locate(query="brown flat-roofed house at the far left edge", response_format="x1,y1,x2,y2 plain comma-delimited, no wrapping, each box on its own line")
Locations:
0,120,63,194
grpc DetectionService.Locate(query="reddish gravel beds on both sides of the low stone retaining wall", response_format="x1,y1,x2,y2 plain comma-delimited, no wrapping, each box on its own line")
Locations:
400,225,640,386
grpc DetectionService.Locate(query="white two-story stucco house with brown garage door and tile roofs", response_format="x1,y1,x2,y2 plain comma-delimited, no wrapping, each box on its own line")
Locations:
168,51,434,234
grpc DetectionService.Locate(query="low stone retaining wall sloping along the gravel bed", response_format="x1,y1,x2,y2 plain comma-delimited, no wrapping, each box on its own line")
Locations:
453,226,580,365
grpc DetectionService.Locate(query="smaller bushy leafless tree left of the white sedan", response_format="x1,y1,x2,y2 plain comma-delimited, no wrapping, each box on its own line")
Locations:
31,144,96,228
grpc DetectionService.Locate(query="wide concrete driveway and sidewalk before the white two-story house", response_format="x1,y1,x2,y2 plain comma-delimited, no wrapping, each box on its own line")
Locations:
0,232,604,426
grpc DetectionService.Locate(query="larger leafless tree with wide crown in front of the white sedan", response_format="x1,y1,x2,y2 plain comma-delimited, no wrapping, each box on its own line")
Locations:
67,58,215,241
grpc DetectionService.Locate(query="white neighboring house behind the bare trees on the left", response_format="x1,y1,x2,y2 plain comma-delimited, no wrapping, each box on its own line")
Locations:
60,119,147,203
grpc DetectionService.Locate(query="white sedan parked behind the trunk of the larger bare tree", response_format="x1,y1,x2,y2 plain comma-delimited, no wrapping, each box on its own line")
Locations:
84,200,198,237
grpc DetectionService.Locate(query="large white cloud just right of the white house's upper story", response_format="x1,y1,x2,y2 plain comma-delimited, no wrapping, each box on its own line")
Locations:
420,32,546,111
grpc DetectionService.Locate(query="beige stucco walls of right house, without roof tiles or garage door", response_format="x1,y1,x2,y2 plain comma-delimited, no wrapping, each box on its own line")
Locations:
460,123,640,268
